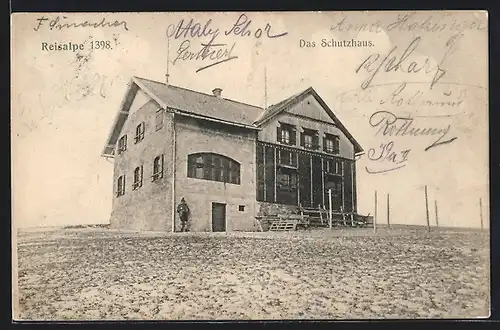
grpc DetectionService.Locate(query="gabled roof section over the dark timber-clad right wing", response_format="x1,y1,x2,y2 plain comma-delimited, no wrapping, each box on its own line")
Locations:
254,87,363,153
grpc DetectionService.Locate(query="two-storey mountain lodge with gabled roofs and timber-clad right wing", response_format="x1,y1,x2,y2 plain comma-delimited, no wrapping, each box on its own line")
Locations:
102,77,362,231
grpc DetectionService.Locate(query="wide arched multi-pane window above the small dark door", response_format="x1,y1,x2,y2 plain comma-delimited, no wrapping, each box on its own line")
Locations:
188,153,241,184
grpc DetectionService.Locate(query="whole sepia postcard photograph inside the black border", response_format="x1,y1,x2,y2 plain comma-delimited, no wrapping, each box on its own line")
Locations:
11,10,490,321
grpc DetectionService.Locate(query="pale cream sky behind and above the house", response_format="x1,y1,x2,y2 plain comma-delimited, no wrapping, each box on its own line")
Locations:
11,12,489,227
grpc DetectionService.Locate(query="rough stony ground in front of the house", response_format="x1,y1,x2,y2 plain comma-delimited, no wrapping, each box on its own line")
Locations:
14,228,489,320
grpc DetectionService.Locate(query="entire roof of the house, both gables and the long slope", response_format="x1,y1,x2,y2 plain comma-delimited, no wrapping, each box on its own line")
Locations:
102,77,363,157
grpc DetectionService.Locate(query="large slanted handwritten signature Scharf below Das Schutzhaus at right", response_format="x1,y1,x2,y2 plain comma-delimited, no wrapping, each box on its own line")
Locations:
355,34,463,89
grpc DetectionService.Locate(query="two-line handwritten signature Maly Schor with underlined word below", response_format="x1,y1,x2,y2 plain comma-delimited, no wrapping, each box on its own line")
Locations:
166,14,288,72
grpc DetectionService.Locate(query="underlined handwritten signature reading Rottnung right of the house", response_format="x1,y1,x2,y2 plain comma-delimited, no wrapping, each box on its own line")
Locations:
369,111,458,151
